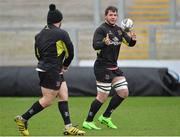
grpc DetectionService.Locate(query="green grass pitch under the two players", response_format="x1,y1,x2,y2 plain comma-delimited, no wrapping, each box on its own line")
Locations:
0,97,180,136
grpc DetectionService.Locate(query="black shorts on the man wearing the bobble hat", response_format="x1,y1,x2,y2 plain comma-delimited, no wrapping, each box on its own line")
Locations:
38,70,64,90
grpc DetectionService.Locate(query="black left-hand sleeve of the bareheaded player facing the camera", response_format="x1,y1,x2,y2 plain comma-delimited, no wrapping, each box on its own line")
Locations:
93,28,106,50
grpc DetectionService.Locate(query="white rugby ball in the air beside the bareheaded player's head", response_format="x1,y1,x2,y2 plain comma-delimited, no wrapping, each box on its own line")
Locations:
121,18,134,32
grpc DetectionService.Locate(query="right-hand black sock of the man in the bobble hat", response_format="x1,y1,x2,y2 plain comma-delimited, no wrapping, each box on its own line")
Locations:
58,101,71,125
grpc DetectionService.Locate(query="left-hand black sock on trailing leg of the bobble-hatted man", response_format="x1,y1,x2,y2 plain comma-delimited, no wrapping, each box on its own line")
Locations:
22,101,44,120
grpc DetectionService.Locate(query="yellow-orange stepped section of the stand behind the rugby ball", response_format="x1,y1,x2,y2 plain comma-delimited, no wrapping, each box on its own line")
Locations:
120,0,170,59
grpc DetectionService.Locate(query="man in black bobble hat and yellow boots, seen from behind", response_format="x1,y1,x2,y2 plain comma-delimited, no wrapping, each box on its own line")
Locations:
15,4,85,136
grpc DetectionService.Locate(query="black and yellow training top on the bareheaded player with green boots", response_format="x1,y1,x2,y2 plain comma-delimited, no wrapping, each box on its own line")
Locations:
93,23,136,67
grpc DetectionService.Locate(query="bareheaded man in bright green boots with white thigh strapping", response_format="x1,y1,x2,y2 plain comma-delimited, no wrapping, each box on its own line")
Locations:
83,6,136,130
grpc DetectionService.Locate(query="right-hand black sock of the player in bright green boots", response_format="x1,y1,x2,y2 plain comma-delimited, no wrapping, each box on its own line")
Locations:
103,94,124,117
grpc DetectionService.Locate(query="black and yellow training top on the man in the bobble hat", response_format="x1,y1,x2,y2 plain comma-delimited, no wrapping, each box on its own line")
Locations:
35,25,74,71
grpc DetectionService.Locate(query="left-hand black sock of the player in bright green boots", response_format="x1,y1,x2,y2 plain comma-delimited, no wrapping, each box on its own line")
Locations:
86,99,102,122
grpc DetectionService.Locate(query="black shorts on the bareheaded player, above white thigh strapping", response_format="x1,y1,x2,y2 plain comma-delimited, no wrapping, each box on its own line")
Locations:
94,67,124,83
